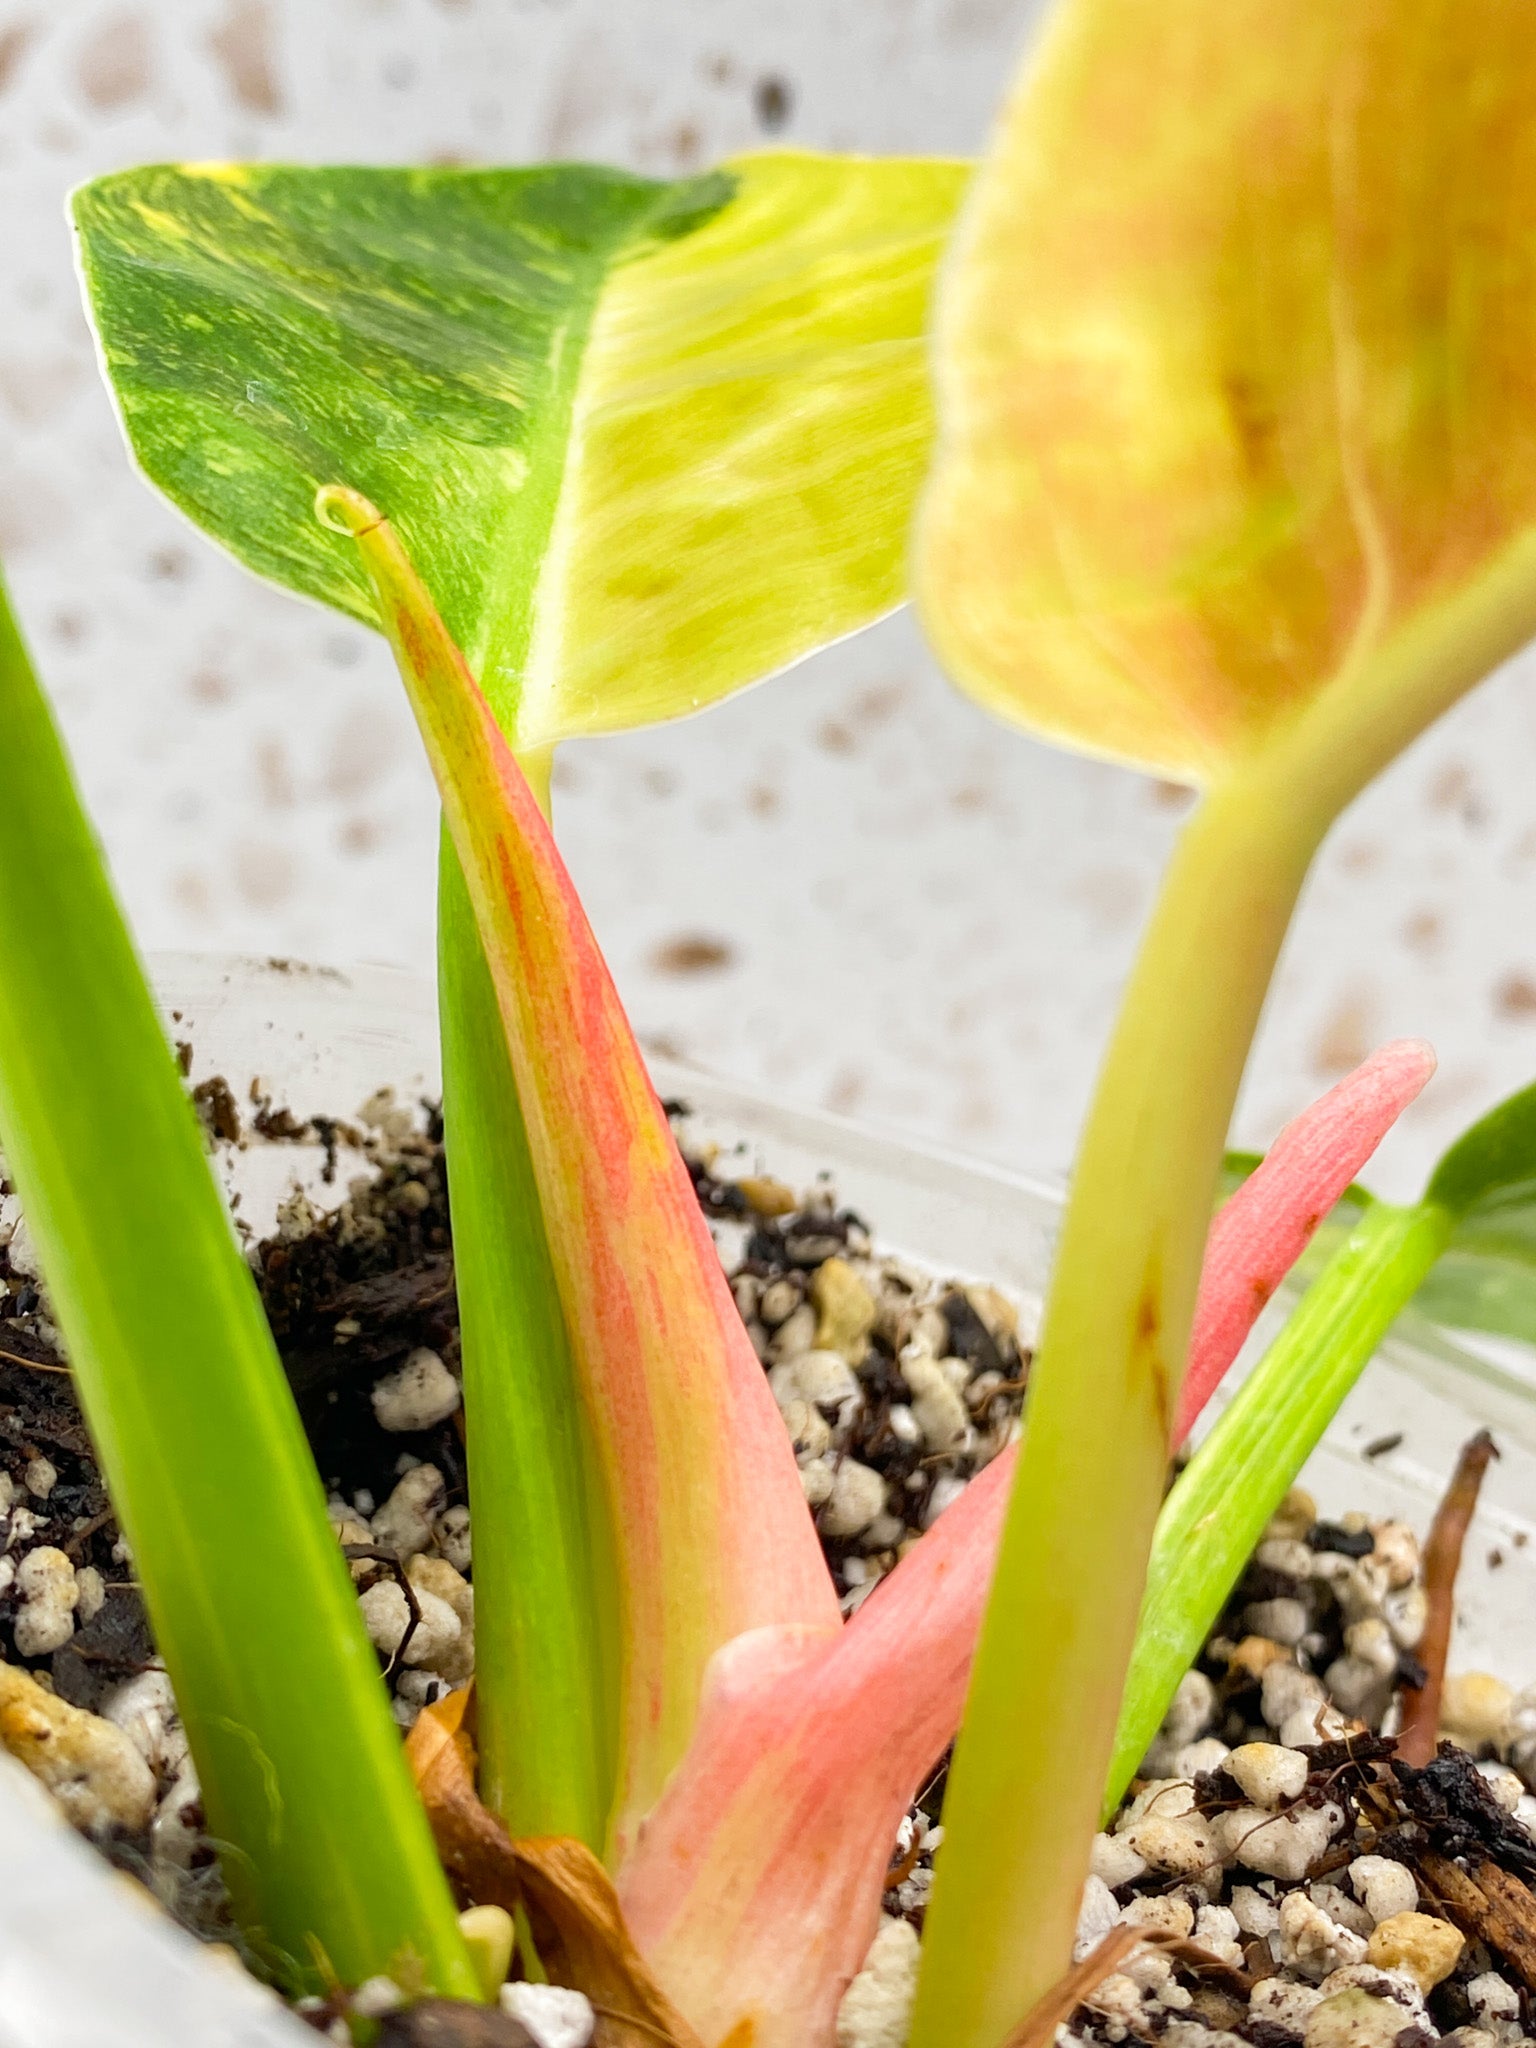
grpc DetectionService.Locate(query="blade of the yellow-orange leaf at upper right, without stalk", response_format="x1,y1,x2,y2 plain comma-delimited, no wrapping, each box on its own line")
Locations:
918,0,1536,780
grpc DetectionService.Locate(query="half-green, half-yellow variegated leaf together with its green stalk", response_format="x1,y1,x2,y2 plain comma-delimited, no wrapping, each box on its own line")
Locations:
76,140,965,1847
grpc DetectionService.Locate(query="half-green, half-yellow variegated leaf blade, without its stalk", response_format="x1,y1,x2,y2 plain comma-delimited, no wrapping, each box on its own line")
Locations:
74,154,965,750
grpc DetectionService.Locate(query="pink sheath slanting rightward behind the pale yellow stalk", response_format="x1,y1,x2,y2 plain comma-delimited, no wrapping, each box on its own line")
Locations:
618,1040,1434,2048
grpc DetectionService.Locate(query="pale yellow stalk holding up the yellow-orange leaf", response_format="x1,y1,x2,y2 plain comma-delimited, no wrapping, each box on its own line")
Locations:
911,764,1321,2048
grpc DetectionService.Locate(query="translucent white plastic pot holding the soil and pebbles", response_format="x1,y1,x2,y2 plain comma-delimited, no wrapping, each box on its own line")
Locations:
0,954,1536,2048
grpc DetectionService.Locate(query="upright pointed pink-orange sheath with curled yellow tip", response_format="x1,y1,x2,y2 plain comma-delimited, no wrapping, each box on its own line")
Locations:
322,487,840,1847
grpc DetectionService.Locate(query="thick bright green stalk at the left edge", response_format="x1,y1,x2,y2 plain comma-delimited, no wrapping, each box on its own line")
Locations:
0,594,477,1997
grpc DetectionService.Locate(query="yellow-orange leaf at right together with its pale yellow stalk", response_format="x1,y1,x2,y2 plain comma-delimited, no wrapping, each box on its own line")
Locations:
913,0,1536,2048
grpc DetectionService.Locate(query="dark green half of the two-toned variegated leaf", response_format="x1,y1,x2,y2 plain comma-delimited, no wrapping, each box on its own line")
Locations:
74,164,721,671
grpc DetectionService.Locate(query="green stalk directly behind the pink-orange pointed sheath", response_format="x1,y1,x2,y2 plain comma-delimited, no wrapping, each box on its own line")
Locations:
438,834,614,1849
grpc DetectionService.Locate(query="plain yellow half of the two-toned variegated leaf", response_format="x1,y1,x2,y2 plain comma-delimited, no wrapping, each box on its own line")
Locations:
518,154,967,745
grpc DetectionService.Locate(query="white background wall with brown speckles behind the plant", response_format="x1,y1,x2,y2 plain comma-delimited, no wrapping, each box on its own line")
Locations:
0,0,1536,1188
